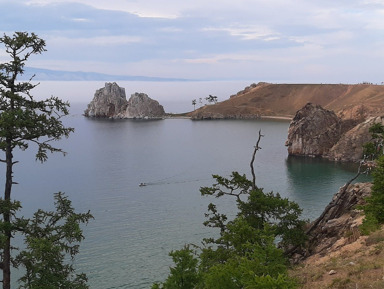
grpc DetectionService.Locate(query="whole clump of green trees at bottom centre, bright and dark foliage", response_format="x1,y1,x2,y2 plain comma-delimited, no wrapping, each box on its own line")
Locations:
152,172,305,289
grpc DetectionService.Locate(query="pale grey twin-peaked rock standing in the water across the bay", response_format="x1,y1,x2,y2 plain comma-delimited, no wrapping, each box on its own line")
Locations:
84,82,165,119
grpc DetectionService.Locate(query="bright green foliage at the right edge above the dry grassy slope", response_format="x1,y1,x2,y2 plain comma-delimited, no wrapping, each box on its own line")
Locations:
361,156,384,234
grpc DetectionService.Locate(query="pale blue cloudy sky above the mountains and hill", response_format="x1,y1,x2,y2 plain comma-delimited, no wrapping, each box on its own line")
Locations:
0,0,384,83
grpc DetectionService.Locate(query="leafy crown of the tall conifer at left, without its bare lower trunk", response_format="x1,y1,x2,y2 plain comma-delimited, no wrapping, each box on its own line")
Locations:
0,32,73,162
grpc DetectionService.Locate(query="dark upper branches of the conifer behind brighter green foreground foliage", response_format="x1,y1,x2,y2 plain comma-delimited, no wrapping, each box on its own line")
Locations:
200,172,305,250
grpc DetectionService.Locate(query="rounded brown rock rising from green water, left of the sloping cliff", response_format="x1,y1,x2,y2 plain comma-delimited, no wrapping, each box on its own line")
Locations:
286,103,342,157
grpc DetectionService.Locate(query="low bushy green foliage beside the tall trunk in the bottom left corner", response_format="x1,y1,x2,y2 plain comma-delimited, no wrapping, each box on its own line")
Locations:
0,193,93,289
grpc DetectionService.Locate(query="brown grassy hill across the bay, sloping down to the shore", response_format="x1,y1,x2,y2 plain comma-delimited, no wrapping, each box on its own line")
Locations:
191,83,384,118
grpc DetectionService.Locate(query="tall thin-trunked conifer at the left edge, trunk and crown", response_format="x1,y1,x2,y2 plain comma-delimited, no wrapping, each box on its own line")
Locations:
0,32,73,289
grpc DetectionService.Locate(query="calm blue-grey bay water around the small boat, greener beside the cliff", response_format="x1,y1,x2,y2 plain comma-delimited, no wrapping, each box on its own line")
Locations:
6,104,366,289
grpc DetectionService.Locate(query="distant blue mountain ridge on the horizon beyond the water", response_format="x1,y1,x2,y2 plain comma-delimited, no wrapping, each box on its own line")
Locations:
20,67,195,81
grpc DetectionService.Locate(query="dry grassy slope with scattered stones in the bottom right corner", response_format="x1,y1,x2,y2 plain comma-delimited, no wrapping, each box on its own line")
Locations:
290,228,384,289
